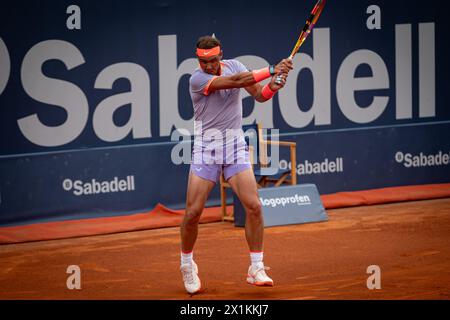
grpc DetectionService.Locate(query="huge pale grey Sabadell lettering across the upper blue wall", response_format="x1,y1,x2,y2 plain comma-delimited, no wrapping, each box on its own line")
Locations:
0,22,436,147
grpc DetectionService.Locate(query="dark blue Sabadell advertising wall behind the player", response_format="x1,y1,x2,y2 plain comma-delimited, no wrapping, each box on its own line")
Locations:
0,0,450,225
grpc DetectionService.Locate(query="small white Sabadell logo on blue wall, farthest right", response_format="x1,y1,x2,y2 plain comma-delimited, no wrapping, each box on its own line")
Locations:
395,151,450,168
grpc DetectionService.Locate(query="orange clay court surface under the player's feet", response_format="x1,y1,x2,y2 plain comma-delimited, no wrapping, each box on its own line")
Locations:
0,198,450,300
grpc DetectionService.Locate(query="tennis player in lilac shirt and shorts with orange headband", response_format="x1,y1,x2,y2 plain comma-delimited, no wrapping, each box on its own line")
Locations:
180,36,292,294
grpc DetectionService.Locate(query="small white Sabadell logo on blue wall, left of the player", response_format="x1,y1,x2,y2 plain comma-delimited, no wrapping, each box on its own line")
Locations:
62,176,135,196
